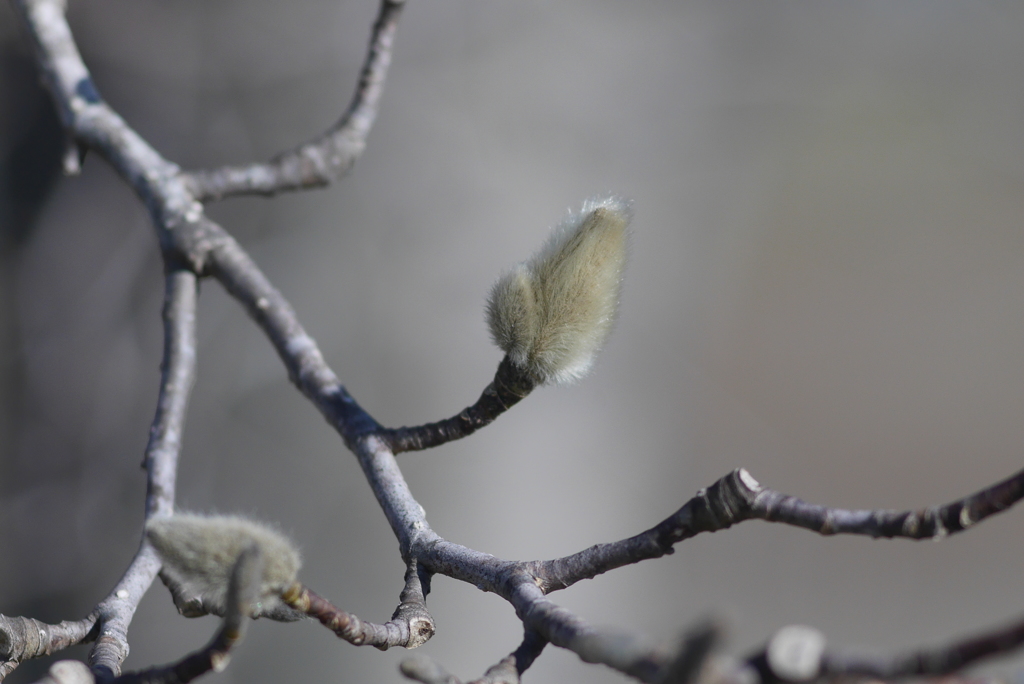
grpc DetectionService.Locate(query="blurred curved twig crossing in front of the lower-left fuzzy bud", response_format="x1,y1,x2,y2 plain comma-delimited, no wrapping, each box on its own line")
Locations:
114,546,263,684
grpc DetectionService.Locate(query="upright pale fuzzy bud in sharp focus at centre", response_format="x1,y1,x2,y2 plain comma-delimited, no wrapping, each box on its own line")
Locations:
487,197,633,384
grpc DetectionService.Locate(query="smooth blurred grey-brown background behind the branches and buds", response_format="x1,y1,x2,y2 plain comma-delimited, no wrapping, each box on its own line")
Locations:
0,0,1024,684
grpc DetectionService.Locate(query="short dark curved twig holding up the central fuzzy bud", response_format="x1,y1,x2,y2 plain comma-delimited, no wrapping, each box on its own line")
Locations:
378,356,537,454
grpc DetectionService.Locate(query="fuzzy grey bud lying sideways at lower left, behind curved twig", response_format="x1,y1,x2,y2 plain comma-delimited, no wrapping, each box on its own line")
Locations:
145,513,302,621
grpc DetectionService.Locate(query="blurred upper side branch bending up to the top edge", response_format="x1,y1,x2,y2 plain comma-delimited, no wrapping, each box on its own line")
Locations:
187,0,404,202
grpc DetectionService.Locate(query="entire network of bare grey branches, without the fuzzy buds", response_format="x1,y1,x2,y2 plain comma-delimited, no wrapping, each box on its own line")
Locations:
9,0,1024,684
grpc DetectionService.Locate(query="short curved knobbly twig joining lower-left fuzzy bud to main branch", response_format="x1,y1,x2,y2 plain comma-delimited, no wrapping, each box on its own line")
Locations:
282,563,434,651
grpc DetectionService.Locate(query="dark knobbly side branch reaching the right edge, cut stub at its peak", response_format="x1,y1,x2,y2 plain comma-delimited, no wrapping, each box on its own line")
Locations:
529,468,1024,592
